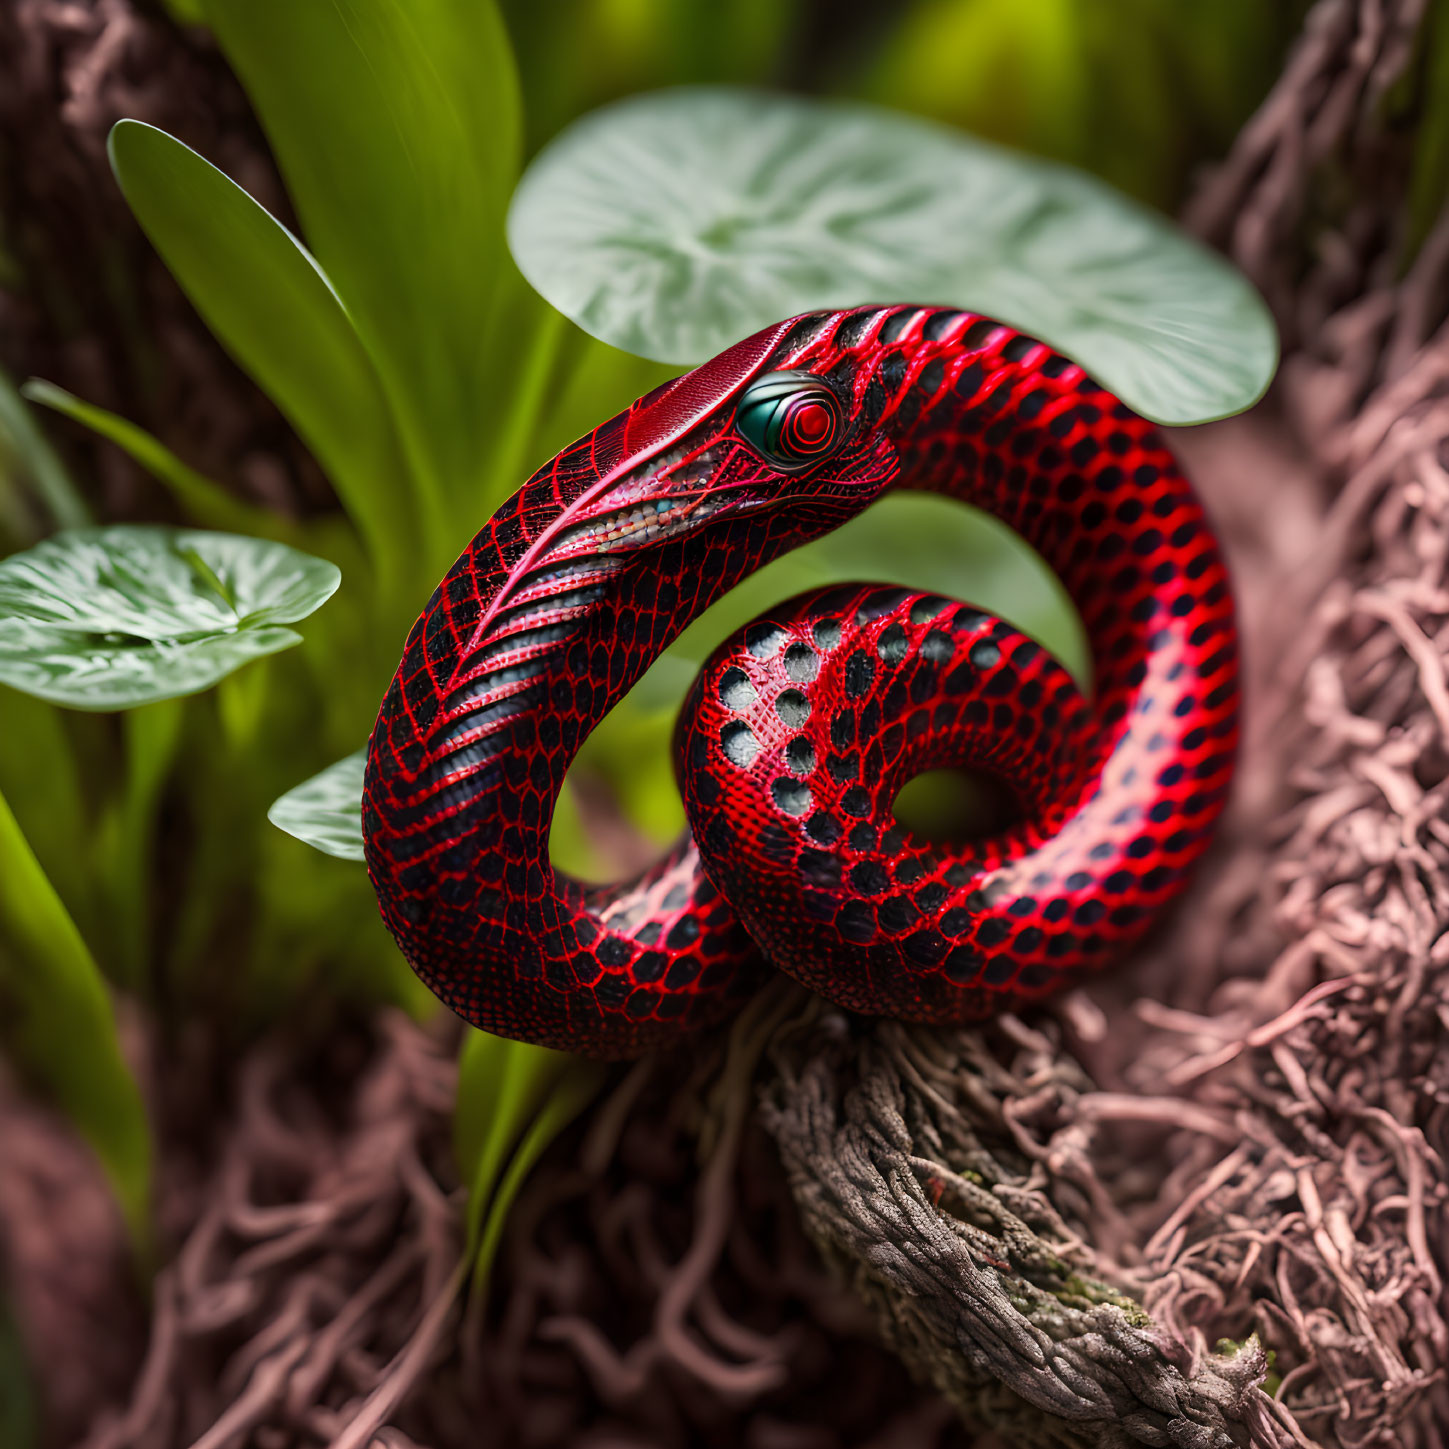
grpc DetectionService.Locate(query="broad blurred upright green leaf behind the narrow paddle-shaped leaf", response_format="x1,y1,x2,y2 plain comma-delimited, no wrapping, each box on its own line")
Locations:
206,0,520,515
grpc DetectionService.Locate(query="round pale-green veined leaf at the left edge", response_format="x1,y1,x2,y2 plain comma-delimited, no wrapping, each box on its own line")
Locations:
0,525,341,710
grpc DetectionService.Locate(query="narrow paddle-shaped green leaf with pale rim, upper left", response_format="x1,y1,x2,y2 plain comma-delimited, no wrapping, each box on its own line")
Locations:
110,120,413,559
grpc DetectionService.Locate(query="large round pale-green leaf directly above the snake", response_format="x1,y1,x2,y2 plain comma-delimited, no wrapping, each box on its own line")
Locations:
509,87,1278,423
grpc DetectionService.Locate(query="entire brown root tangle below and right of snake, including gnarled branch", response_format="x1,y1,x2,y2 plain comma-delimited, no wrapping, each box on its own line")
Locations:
0,0,1449,1449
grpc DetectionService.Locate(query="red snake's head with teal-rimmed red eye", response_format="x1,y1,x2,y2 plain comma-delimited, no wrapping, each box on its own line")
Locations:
551,314,897,561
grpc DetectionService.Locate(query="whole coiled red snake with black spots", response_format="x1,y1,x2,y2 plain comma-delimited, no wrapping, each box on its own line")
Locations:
362,306,1237,1056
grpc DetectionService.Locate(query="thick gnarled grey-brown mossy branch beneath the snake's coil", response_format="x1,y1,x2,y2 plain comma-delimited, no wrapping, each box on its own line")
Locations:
764,1013,1295,1449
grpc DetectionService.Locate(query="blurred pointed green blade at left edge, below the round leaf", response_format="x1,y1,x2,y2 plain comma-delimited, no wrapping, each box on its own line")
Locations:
0,796,151,1246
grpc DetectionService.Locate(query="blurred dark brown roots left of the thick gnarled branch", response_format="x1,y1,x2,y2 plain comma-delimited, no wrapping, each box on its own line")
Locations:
8,993,965,1449
